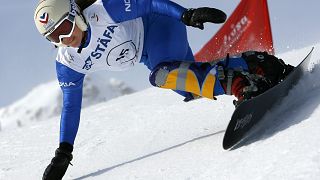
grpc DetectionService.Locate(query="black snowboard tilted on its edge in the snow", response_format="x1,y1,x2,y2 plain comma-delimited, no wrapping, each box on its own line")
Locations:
223,48,314,150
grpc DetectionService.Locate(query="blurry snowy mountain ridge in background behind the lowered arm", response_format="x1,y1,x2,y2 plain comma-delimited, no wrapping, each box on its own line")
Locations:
0,73,134,131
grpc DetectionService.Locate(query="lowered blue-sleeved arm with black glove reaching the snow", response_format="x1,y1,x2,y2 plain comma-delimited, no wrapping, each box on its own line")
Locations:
42,62,85,180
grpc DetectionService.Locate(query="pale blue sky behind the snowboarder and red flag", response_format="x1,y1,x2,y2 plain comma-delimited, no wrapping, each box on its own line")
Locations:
0,0,320,107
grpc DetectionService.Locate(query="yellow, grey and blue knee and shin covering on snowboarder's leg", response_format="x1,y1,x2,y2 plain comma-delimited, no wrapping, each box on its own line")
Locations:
149,62,224,99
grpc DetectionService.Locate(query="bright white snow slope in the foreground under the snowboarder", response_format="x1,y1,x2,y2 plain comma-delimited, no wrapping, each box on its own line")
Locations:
0,45,320,180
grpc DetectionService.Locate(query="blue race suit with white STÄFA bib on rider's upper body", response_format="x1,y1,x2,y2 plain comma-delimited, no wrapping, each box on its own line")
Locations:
56,0,194,144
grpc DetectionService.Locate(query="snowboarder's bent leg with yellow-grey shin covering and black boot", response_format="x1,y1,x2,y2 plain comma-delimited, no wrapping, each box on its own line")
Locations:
150,51,293,104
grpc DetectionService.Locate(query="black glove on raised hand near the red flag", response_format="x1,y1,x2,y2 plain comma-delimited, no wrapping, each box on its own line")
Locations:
181,7,227,29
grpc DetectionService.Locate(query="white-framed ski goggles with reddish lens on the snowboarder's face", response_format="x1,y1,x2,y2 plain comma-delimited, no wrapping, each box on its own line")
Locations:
44,13,76,45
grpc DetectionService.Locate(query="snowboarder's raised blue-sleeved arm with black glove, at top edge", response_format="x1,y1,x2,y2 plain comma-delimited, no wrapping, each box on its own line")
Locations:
102,0,227,29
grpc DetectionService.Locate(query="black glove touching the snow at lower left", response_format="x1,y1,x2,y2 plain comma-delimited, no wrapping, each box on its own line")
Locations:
42,143,73,180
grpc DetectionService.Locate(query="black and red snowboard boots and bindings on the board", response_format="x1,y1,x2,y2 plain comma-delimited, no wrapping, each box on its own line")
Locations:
220,51,294,107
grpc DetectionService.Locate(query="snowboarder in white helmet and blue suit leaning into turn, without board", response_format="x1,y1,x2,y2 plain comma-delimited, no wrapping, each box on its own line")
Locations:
34,0,292,180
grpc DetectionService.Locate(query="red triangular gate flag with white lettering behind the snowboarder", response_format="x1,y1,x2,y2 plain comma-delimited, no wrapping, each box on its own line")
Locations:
195,0,274,62
